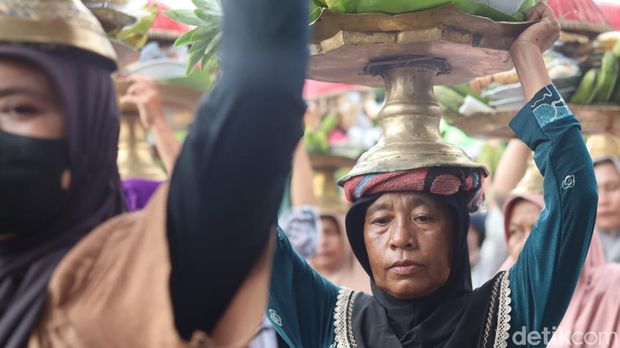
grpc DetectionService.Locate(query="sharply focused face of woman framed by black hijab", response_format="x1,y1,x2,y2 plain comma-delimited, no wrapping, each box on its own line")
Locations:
364,192,453,299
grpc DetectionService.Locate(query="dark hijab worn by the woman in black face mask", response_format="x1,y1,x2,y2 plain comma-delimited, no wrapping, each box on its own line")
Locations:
0,44,124,348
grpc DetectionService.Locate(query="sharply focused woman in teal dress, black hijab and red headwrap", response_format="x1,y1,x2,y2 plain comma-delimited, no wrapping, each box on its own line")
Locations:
267,3,597,348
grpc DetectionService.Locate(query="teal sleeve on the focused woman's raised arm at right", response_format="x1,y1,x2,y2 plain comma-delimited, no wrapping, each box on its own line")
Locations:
509,86,597,343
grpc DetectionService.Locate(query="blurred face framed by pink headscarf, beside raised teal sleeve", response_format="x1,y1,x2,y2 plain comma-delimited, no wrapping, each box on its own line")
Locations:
508,199,541,261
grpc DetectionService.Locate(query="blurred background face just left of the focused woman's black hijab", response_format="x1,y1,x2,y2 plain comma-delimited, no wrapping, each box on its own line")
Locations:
310,217,344,273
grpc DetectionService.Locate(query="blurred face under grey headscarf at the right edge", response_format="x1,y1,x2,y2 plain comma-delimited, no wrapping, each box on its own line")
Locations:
594,162,620,231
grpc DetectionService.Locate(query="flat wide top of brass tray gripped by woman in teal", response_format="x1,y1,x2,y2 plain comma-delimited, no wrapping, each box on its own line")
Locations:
308,5,531,87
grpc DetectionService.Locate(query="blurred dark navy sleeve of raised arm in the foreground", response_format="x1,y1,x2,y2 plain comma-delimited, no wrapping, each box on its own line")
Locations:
167,0,308,339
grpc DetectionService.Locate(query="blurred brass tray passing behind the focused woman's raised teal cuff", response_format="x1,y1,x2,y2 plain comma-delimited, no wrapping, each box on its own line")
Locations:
449,105,620,138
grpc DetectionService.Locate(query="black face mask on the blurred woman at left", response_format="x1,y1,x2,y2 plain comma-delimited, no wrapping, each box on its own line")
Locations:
0,131,69,235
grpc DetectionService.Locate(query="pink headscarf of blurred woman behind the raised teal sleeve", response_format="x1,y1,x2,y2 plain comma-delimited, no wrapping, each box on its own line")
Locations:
500,194,620,348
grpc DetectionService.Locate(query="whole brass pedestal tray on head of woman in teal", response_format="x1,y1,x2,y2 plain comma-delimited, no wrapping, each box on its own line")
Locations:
308,6,531,184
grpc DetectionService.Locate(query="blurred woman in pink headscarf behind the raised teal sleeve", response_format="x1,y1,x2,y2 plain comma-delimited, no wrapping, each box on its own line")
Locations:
501,142,620,348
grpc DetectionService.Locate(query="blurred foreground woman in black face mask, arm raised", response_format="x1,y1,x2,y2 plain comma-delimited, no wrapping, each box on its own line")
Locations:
0,0,307,348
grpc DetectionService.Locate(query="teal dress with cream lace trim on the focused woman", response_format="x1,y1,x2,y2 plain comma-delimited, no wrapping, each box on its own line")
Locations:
267,86,597,348
